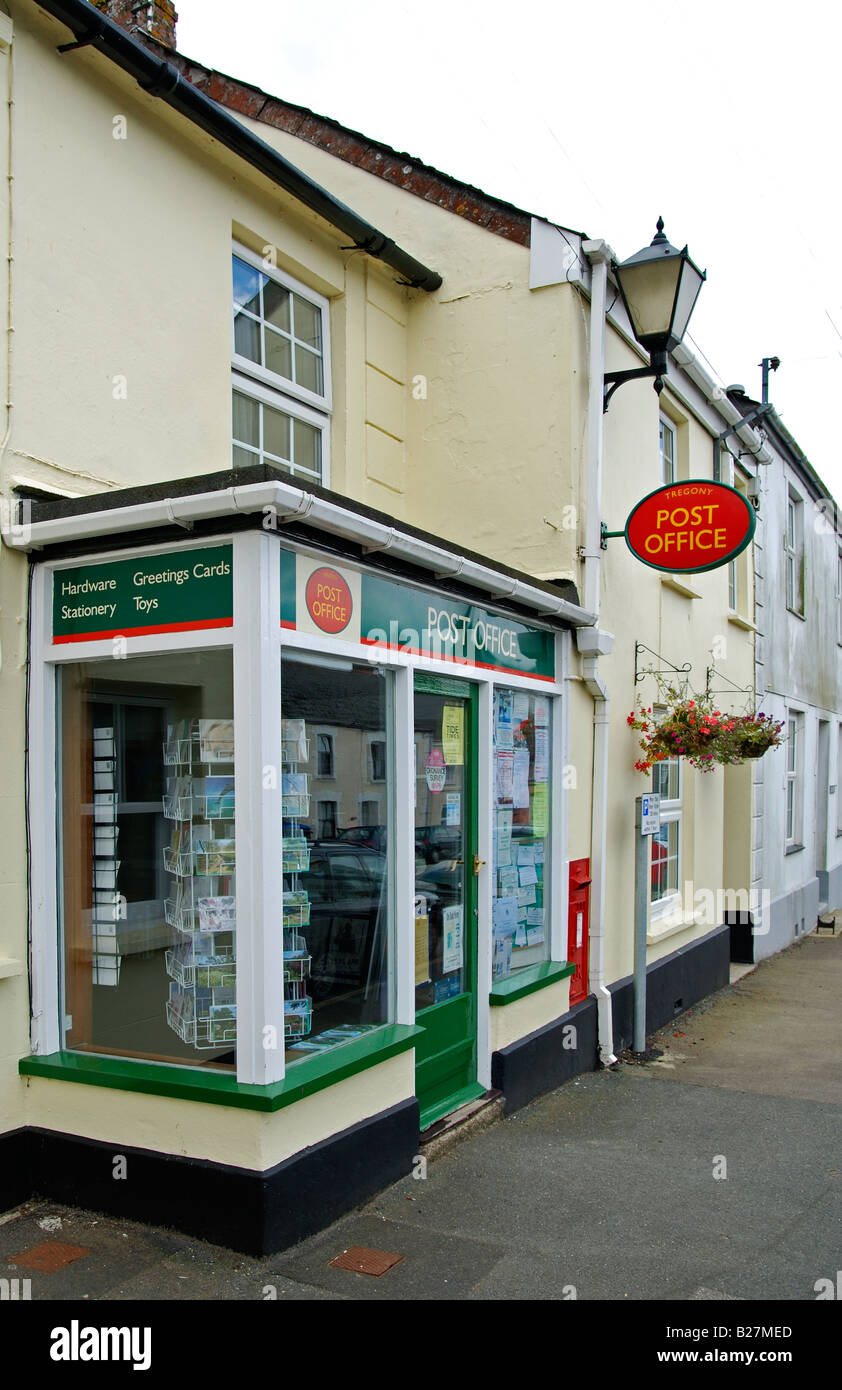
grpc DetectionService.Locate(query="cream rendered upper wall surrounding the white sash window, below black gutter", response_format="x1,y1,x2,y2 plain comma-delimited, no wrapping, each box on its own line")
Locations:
4,6,425,506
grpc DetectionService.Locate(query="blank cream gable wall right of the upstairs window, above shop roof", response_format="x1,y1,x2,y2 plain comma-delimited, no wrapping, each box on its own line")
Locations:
229,109,585,577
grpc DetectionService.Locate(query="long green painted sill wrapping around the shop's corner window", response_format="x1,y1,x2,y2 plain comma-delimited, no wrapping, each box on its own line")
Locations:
18,1024,424,1112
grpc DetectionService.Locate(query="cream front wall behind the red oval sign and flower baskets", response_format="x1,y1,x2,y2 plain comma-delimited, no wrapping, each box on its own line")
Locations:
600,334,753,980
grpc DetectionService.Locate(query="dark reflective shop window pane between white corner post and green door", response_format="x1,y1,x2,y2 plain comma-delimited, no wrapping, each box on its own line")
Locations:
281,652,395,1063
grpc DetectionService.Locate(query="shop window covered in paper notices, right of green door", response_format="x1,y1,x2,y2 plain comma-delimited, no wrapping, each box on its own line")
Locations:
492,689,552,980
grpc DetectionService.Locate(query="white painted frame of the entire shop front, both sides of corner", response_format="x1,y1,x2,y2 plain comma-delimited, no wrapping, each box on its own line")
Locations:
28,531,574,1098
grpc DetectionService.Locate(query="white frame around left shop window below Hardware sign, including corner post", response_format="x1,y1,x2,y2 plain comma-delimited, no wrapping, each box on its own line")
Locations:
28,531,285,1086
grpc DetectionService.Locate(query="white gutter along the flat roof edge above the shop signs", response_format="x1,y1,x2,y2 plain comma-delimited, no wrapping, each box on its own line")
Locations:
3,482,593,627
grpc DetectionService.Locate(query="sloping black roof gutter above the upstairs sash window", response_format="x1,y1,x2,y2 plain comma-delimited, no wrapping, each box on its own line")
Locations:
38,0,442,292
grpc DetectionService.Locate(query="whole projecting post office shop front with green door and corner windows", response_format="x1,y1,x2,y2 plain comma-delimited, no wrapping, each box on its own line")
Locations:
9,480,586,1251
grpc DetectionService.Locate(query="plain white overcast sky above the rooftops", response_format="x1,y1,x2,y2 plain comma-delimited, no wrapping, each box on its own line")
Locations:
176,0,842,500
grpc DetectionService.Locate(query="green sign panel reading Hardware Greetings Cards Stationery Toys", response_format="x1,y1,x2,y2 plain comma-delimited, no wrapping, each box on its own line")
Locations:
53,545,233,645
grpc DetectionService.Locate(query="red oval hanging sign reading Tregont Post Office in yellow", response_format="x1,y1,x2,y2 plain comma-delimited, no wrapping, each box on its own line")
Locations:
625,478,754,574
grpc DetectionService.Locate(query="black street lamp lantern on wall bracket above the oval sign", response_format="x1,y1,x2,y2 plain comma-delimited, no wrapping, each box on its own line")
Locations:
603,217,707,411
